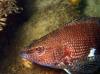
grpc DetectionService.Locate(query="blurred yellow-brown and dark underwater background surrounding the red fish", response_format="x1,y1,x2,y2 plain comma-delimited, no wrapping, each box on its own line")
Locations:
0,0,100,74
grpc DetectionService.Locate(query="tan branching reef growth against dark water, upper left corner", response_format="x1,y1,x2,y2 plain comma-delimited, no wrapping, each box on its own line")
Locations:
0,0,19,31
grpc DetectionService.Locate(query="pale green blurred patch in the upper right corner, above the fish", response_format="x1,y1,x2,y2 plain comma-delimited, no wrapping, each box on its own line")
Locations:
84,0,100,17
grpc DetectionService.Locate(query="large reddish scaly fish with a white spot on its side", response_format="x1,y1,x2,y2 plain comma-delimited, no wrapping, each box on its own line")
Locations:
20,17,100,74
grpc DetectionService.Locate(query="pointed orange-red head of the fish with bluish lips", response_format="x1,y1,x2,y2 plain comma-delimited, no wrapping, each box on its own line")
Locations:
20,46,57,67
